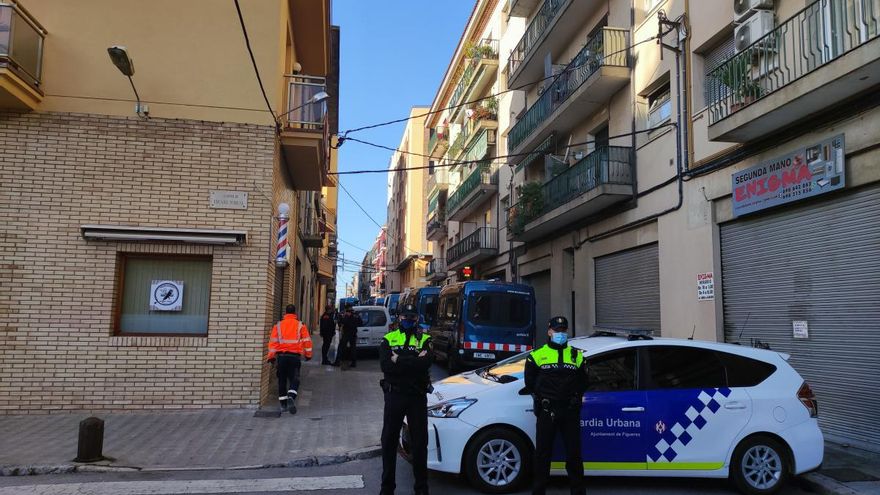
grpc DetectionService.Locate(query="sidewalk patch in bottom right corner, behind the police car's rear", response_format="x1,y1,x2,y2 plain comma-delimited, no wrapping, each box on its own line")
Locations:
799,442,880,495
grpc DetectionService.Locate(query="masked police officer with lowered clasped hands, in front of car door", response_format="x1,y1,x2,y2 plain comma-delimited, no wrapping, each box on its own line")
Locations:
525,316,587,495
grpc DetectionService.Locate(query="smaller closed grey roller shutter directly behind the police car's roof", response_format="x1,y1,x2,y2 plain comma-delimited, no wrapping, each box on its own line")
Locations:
596,244,660,335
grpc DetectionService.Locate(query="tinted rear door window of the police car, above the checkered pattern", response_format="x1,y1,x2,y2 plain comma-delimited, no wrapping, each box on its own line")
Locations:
647,346,726,388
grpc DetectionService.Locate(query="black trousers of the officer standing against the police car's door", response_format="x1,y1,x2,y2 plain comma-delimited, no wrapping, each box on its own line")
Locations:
532,407,584,495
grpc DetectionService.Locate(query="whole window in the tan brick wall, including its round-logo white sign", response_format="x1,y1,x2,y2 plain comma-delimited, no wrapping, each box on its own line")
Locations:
115,255,212,335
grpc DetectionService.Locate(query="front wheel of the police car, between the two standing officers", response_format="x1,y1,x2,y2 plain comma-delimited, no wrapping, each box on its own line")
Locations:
463,427,532,493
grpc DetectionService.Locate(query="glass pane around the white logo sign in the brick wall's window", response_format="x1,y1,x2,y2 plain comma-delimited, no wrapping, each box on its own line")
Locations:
119,257,211,335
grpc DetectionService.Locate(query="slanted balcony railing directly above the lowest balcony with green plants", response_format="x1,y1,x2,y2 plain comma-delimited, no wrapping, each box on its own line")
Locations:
507,28,629,153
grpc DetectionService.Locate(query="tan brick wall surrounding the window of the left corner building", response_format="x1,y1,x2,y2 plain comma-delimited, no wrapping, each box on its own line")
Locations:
0,112,280,414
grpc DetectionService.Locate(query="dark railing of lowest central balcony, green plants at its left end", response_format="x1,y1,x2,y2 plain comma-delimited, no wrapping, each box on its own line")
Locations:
508,146,633,234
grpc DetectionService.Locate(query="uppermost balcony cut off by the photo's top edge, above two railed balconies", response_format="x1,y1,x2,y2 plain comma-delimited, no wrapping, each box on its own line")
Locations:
507,0,606,88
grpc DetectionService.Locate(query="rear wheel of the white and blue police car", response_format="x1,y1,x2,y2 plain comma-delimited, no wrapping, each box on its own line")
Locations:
730,435,791,495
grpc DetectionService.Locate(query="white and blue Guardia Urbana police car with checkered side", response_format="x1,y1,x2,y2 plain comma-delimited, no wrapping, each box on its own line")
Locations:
410,333,824,494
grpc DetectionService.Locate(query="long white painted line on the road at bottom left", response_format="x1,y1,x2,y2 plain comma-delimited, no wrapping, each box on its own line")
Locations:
0,475,364,495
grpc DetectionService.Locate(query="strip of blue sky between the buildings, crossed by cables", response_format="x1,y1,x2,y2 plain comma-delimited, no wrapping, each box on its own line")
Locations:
333,0,482,297
